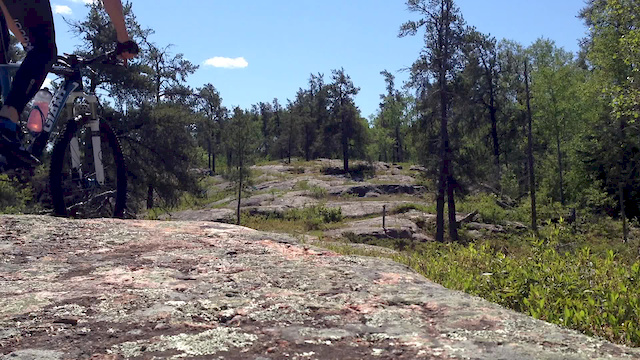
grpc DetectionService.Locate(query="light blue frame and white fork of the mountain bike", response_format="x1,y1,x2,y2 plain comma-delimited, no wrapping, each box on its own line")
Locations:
0,63,105,185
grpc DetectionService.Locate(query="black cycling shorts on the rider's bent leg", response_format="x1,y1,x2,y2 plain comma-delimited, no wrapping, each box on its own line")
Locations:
0,0,57,113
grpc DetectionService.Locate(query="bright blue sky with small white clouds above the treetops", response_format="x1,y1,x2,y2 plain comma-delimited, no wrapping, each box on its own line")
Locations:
46,0,586,117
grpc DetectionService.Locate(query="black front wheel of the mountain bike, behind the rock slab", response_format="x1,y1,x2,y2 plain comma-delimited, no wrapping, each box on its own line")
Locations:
49,119,127,218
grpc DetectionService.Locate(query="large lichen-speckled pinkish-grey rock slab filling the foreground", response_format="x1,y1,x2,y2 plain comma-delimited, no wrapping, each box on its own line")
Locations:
0,216,640,360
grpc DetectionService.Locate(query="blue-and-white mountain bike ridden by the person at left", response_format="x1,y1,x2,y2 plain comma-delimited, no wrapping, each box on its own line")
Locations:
0,51,127,218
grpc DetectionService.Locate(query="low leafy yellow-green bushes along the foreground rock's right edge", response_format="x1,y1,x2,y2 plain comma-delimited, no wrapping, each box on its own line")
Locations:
405,224,640,346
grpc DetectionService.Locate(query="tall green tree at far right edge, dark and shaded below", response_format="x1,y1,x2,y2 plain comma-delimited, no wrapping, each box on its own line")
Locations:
580,0,640,221
